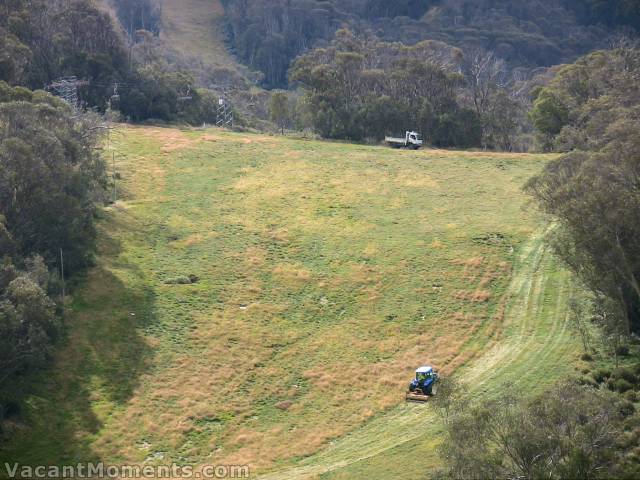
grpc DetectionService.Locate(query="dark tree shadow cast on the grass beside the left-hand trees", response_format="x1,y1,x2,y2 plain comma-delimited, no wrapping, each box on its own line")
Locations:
0,217,156,466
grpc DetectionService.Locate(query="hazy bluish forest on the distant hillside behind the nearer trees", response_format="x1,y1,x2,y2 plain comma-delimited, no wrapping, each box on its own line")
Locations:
224,0,640,87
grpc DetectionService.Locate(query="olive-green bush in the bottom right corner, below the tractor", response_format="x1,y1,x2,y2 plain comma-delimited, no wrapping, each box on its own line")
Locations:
440,382,635,478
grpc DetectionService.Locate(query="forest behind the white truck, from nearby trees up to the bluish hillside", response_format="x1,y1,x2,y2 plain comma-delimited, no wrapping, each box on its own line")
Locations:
216,0,640,151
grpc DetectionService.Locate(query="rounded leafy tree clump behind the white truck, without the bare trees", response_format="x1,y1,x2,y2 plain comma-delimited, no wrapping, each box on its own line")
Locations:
290,30,484,148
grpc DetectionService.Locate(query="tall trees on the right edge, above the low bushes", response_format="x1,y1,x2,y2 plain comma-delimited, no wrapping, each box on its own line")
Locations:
527,46,640,337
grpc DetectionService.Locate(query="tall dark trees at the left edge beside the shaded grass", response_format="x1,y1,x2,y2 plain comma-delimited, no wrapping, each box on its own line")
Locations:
0,82,106,402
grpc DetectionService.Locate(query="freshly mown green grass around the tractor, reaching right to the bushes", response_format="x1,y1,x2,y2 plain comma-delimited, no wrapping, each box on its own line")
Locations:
268,227,580,479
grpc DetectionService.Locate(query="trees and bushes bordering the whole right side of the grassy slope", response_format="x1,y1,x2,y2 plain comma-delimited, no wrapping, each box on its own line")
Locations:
435,42,640,479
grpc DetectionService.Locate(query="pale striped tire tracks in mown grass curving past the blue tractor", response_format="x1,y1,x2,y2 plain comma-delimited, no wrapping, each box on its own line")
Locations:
260,231,576,480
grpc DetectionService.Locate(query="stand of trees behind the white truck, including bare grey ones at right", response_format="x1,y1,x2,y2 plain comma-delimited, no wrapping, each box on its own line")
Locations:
289,30,528,150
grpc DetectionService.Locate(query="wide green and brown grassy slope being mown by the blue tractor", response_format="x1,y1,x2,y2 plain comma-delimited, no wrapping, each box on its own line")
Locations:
1,128,572,478
